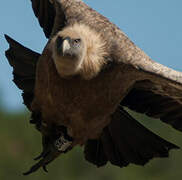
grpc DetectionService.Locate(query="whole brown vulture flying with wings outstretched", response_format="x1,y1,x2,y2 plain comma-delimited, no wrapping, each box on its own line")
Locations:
5,0,182,175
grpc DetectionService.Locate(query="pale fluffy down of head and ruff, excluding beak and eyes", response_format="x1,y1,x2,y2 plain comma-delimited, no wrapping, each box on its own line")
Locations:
53,24,107,79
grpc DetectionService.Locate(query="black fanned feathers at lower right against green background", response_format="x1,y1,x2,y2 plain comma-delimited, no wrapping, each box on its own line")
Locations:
85,107,178,167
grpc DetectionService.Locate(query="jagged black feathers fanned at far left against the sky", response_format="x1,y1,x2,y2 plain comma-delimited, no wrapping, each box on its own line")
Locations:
5,35,40,108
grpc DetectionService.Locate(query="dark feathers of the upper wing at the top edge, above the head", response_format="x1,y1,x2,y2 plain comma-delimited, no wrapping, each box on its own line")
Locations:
31,0,56,38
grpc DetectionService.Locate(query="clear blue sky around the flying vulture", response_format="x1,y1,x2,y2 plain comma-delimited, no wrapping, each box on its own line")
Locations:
0,0,182,111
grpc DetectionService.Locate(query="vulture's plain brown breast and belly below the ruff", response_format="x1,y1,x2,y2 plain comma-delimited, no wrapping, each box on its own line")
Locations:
32,46,135,144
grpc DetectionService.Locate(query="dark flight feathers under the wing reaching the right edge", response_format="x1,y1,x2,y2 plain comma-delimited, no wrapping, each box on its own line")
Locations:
121,80,182,131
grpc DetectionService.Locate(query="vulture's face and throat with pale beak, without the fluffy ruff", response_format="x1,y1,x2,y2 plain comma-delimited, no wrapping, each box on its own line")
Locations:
53,30,86,77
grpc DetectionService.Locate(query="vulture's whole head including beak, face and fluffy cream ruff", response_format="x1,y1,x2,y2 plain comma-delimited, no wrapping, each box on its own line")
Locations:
52,25,106,79
